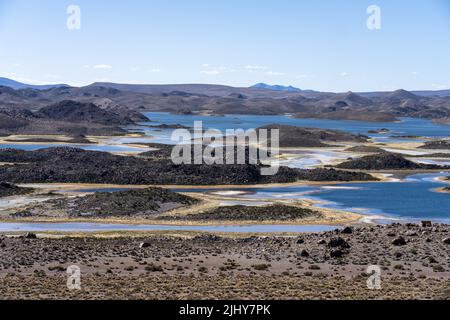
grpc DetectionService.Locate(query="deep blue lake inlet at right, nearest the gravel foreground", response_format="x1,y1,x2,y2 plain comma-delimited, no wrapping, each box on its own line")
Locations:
175,173,450,223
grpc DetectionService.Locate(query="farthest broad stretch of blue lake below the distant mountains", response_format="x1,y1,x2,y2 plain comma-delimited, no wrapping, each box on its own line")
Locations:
141,112,450,143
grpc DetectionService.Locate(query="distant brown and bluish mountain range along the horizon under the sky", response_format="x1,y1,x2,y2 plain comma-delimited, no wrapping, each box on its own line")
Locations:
0,78,450,123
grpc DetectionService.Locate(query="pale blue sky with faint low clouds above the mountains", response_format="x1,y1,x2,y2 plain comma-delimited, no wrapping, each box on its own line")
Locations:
0,0,450,91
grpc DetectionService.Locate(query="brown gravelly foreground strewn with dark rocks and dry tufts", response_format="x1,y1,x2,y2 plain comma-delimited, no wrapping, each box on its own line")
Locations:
0,224,450,300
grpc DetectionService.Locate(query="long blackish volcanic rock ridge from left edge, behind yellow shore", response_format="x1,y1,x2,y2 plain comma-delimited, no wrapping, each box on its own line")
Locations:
0,148,374,185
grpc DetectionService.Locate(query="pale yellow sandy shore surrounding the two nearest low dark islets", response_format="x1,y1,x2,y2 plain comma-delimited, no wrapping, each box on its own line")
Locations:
0,174,432,226
